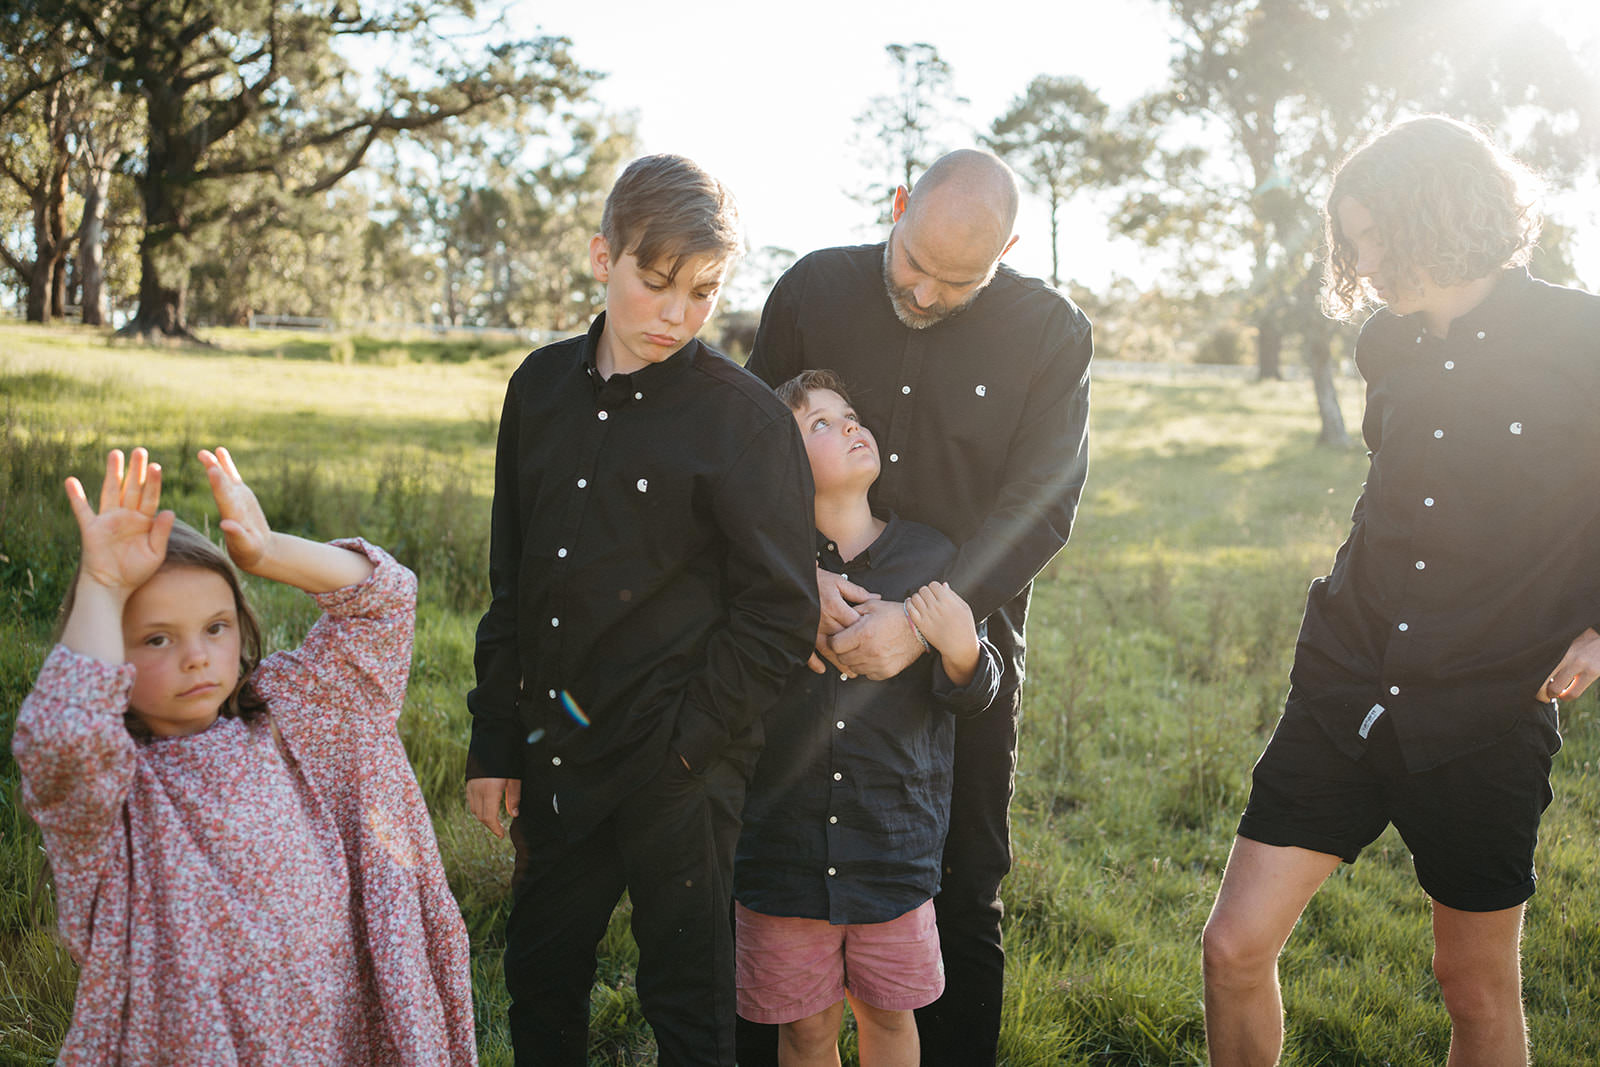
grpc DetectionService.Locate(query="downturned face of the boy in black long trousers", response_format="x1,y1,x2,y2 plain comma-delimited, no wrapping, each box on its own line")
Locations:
589,234,728,376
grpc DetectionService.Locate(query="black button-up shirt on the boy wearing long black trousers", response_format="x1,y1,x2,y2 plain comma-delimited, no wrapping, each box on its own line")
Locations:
467,314,819,837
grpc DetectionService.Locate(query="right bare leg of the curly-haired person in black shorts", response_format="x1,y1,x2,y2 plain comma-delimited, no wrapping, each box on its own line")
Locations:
1434,901,1528,1067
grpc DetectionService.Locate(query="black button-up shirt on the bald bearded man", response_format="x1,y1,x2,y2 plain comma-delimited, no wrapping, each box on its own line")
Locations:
750,243,1093,701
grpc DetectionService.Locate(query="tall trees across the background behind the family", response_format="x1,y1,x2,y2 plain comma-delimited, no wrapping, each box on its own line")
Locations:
0,0,1600,445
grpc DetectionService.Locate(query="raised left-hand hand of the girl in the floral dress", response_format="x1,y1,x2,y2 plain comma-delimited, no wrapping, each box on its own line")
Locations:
67,448,173,595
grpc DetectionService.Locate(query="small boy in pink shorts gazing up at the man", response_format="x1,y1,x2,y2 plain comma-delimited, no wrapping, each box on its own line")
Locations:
734,370,1002,1067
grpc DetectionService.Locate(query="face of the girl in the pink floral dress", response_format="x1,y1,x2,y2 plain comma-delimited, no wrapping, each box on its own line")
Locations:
122,566,240,737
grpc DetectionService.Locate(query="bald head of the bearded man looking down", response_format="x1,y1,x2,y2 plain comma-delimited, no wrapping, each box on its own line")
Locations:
883,149,1018,330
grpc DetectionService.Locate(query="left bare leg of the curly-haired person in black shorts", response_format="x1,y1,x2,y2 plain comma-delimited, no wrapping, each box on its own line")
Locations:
1202,837,1339,1067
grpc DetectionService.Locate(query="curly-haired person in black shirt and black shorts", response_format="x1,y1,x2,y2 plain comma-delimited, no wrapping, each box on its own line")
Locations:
1205,117,1600,1064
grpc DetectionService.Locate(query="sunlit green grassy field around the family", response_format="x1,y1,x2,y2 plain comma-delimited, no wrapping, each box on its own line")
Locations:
0,325,1600,1067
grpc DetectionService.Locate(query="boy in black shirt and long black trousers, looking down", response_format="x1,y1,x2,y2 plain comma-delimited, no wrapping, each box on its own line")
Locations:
467,157,818,1065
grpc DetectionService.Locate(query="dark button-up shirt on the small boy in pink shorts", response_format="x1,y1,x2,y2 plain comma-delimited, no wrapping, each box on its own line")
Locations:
734,515,1002,923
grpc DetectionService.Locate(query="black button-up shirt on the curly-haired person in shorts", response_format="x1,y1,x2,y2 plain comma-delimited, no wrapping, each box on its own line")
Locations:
1288,270,1600,771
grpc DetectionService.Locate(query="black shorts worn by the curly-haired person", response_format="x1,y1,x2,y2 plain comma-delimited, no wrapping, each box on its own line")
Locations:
1238,703,1562,912
